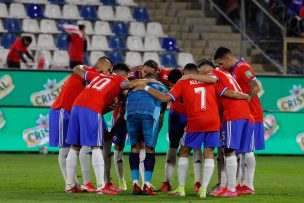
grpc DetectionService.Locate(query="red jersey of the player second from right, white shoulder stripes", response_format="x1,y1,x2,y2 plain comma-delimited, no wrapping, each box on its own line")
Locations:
210,70,250,121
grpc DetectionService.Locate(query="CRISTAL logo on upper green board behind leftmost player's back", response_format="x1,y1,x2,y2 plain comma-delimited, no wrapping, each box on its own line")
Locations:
31,77,68,106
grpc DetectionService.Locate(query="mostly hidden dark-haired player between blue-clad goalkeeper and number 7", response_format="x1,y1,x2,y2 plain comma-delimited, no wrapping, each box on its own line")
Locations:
158,68,202,192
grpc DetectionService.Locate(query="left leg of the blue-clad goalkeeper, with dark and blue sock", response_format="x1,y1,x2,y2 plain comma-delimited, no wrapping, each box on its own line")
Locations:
126,115,142,195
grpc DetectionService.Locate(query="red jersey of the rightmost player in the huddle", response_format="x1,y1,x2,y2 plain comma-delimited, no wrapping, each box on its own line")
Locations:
230,58,263,122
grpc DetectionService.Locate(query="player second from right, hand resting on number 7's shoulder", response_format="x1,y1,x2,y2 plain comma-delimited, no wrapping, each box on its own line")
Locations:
185,59,252,197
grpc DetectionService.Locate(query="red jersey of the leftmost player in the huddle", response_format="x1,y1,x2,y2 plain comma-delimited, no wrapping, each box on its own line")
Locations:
52,67,96,111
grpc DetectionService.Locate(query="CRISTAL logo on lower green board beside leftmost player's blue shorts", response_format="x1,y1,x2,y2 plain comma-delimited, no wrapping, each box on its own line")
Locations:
23,114,49,148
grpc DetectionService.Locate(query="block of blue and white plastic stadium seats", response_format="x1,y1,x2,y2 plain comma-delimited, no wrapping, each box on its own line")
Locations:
0,0,193,69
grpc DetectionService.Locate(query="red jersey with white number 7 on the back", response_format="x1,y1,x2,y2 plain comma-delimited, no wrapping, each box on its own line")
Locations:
168,79,222,132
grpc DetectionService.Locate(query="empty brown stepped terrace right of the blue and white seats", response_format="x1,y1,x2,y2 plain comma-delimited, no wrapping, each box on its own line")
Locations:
136,0,277,74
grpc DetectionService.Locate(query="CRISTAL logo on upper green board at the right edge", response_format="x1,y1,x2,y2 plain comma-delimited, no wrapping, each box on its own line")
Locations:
277,85,304,111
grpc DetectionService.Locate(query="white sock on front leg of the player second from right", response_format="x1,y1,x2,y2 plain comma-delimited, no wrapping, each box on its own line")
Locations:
226,155,237,192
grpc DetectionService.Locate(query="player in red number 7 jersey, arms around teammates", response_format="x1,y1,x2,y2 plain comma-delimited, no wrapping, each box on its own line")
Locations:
138,64,248,198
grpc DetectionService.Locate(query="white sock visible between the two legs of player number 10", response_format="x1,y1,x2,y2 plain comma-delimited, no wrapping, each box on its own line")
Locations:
79,146,91,184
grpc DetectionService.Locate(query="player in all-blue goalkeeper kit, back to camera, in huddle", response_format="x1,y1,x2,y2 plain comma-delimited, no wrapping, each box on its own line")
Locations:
125,72,167,195
